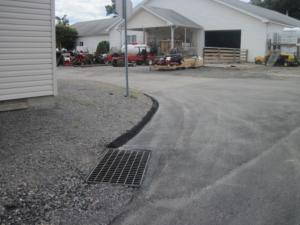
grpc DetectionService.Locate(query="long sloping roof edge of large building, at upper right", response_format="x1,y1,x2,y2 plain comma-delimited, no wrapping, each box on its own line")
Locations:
215,0,300,27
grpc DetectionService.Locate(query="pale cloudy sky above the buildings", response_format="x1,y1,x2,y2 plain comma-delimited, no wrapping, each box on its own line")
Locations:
55,0,250,24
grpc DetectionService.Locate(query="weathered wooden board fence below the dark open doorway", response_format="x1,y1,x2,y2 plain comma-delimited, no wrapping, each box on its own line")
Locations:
203,48,248,64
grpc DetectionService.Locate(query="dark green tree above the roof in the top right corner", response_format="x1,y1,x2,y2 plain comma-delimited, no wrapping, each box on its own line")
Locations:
250,0,300,20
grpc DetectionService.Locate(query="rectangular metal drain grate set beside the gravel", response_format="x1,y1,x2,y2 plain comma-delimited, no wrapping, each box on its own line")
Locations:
86,149,151,187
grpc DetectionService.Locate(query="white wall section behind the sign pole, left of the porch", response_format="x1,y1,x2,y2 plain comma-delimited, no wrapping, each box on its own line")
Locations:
109,27,143,50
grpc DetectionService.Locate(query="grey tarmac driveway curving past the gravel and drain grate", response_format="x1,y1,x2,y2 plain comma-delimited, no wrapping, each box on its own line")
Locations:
58,68,300,225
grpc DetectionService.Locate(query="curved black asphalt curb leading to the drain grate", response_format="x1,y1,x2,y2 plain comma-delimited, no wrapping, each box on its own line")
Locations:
106,94,159,148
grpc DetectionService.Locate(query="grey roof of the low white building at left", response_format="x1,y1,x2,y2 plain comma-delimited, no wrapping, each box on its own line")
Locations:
70,17,120,36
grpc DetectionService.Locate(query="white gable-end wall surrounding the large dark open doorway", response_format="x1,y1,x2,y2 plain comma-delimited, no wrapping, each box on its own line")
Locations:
147,0,266,61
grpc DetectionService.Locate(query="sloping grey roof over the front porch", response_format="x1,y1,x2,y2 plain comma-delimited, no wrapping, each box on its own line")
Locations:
141,5,202,28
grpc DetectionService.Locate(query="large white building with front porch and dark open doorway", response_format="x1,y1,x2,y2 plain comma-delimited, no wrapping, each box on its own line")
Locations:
120,0,300,62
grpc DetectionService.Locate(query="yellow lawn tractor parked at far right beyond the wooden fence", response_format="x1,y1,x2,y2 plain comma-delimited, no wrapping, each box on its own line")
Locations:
255,51,300,67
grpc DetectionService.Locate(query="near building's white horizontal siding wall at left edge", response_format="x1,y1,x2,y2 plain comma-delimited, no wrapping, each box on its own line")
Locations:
0,0,57,101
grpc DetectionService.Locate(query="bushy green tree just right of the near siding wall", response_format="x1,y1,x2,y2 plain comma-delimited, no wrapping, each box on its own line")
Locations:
55,24,78,49
